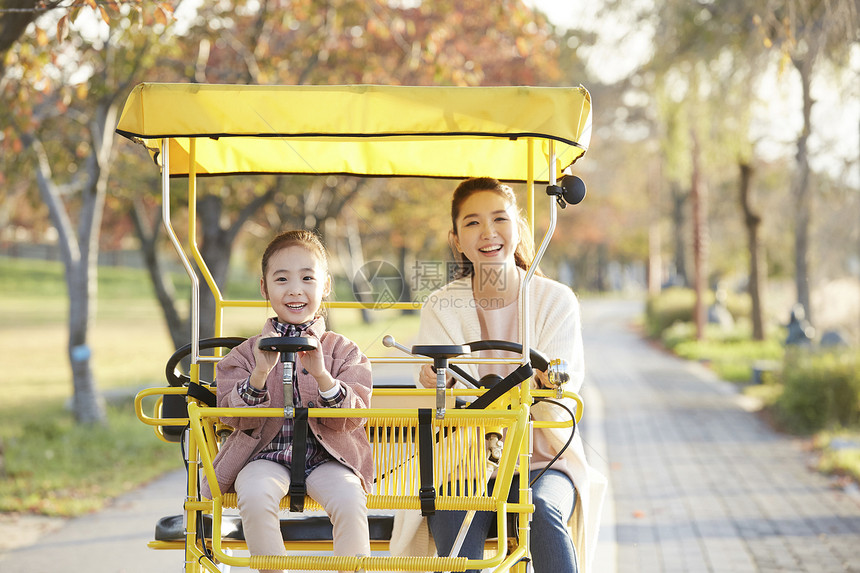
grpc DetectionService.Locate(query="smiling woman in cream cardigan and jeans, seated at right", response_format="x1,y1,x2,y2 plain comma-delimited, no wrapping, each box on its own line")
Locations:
391,177,606,573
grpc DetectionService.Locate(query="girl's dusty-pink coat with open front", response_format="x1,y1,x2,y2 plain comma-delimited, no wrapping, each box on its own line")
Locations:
201,320,373,497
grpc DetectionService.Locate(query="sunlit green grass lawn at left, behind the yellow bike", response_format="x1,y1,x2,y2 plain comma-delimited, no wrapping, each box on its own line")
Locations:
0,257,418,516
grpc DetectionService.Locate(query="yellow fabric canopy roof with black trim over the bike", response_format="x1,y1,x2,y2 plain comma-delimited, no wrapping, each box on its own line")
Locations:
116,83,591,181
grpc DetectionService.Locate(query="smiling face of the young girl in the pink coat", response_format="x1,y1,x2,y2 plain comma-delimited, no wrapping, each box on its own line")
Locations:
260,245,331,324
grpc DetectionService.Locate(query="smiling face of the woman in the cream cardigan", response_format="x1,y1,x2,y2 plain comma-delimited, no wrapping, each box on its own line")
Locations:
453,191,520,265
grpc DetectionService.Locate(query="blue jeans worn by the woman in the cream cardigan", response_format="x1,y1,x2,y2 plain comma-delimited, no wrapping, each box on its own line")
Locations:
428,469,578,573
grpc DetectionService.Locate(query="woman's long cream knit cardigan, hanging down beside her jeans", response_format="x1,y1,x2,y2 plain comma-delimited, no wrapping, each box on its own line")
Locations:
391,271,607,573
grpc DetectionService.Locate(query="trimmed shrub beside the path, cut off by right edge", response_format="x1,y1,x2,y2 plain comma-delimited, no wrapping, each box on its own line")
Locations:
775,348,860,433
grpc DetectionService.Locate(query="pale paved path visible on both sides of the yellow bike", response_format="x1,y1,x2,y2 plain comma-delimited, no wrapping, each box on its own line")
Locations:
0,300,860,573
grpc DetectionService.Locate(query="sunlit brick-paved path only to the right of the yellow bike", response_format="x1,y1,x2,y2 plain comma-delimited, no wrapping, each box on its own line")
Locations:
583,300,860,573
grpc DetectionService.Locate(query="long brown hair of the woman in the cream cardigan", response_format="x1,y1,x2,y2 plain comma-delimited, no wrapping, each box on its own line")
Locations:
451,177,535,279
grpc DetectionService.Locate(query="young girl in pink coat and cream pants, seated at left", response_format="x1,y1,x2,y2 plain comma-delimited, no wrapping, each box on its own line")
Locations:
203,231,373,572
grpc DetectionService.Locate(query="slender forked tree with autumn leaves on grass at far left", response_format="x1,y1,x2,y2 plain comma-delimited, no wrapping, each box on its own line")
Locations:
0,2,176,423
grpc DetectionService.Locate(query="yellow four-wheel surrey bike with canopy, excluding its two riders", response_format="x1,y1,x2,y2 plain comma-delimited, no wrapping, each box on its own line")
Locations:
117,83,591,573
